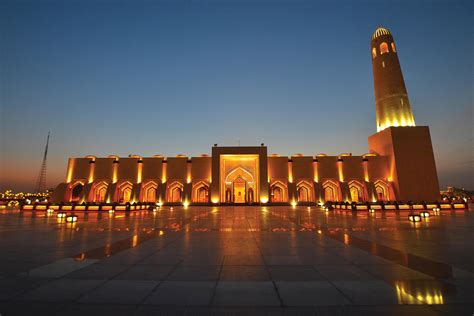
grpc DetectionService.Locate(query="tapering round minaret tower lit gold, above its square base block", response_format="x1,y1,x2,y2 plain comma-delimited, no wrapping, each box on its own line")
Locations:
370,27,415,132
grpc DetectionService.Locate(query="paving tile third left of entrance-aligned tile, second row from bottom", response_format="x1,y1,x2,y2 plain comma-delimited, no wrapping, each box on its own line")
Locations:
17,278,104,302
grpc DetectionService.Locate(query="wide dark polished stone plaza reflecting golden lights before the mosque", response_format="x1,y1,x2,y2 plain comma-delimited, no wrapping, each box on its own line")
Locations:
0,207,474,316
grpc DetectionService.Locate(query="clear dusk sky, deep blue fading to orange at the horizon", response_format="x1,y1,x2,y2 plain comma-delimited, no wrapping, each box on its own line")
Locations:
0,0,474,189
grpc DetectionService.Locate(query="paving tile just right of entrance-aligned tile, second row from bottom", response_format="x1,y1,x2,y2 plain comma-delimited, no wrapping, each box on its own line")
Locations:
276,281,351,306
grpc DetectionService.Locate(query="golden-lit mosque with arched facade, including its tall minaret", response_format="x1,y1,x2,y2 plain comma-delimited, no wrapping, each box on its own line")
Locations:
52,27,439,205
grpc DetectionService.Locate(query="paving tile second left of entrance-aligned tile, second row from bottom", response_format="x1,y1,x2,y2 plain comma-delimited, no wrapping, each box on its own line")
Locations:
78,280,159,304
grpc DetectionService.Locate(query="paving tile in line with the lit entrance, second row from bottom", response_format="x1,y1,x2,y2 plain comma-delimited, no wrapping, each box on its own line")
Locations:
212,281,280,306
